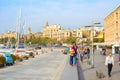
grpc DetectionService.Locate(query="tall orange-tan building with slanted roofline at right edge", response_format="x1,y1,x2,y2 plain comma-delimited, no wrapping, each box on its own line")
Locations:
104,6,120,43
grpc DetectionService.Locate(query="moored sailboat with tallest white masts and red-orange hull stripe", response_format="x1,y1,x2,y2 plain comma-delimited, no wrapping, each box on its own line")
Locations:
14,9,28,57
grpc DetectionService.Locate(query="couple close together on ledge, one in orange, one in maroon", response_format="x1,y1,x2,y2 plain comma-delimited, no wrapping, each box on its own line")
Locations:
69,43,78,66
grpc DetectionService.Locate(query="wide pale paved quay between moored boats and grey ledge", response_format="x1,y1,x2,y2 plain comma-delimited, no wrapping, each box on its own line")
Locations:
0,49,68,80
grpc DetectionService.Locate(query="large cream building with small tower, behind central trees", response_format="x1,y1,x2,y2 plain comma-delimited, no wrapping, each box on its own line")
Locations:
43,22,71,41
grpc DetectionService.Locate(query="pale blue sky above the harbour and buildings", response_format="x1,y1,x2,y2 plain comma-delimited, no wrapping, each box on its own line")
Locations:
0,0,120,33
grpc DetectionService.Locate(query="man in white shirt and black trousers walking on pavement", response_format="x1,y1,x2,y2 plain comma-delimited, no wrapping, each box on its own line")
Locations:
105,53,114,77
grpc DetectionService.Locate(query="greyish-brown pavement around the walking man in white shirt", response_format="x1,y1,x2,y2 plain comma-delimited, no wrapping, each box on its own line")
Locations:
81,51,120,80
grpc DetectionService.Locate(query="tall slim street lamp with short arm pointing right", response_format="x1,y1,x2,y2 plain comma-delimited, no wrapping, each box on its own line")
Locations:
91,22,100,68
